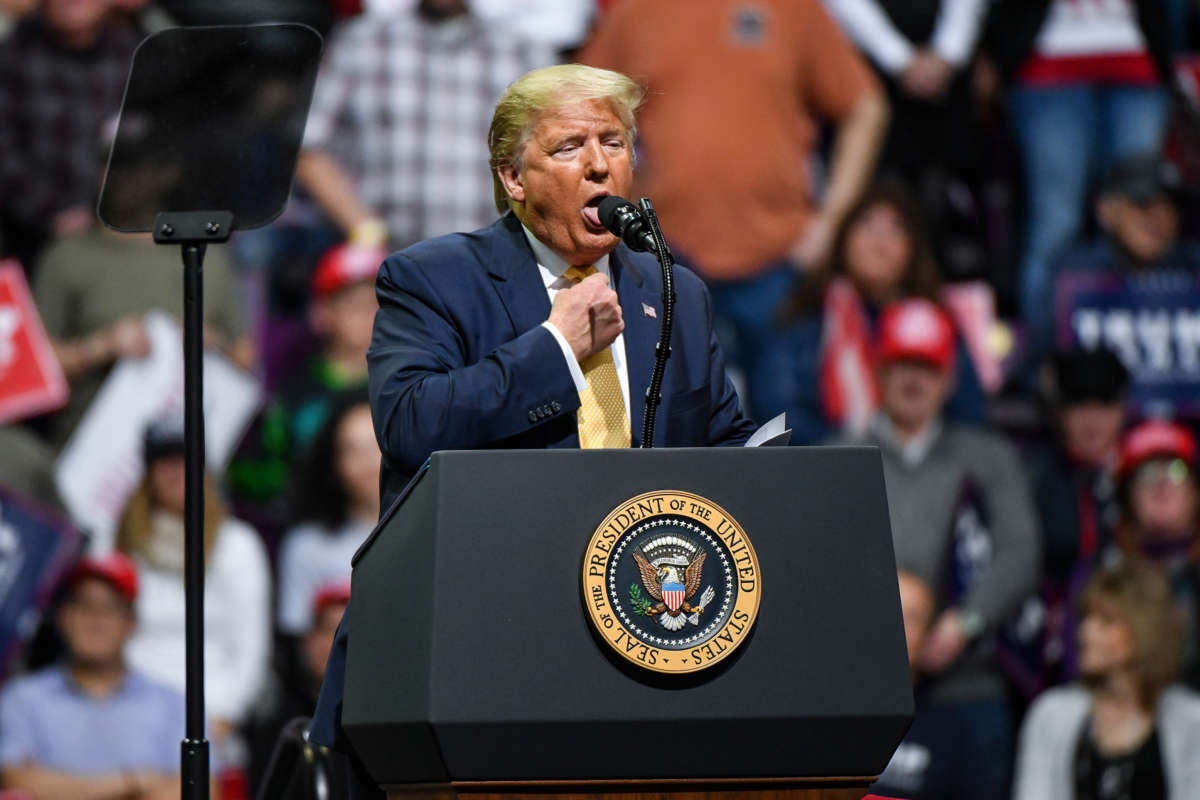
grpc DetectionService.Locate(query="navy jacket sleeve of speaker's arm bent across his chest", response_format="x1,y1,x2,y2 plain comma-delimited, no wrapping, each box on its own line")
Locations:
367,253,580,473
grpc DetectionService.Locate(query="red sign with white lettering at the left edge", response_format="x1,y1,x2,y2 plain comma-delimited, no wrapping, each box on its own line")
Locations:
0,259,67,425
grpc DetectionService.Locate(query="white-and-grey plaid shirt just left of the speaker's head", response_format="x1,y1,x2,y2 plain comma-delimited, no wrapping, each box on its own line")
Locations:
305,13,554,247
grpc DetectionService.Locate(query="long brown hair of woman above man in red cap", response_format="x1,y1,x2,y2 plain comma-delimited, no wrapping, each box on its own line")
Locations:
781,179,942,320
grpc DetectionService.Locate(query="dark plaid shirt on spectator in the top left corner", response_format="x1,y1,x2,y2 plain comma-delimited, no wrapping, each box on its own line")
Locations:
0,19,139,230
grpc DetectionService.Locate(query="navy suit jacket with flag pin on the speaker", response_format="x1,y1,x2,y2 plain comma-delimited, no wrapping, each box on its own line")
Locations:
310,213,754,758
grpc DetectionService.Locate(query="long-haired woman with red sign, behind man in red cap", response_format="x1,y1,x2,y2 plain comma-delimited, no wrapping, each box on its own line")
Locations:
763,182,984,444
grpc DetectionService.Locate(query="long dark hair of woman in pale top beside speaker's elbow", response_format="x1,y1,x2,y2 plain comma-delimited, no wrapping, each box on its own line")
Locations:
292,389,370,528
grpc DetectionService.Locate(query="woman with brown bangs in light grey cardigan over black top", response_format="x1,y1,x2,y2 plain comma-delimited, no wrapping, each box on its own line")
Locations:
1014,559,1200,800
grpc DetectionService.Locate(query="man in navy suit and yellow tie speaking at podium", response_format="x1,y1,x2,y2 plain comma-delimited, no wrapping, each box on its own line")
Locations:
312,65,754,791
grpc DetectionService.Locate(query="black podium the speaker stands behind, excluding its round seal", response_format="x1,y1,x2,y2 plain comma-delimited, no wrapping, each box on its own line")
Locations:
342,447,913,798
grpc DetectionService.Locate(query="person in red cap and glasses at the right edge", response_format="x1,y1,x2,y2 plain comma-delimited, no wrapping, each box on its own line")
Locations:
1116,420,1200,687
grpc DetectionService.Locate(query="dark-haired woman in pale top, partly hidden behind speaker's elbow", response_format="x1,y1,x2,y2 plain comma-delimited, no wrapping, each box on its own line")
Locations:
280,390,380,636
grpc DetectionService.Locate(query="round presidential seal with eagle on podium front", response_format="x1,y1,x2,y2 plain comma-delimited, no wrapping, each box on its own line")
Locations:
583,491,762,673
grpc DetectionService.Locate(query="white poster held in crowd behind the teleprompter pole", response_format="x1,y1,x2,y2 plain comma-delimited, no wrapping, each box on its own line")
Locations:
55,311,262,553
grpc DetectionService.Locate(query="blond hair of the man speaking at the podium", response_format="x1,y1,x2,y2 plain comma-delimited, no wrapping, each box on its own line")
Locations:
487,64,646,213
